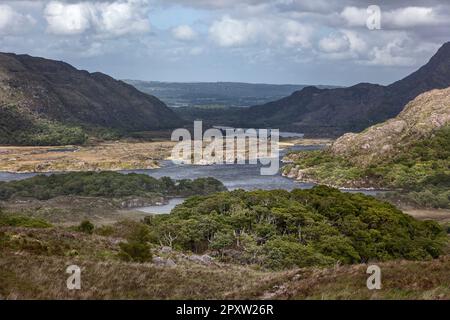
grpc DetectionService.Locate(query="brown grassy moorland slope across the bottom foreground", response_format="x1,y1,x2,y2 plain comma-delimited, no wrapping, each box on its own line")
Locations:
0,221,450,299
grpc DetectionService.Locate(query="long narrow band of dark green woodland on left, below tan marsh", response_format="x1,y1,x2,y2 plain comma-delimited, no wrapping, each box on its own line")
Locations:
0,171,226,200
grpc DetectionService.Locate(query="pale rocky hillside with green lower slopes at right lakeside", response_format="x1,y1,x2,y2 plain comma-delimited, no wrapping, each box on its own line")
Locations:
283,87,450,208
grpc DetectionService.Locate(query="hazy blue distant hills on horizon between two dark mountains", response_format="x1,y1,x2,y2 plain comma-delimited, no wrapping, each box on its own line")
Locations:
124,80,336,108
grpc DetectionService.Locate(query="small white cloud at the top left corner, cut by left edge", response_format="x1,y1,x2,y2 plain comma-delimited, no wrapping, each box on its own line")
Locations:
0,4,36,34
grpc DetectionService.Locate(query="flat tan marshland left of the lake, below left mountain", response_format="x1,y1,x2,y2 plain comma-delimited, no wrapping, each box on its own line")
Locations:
0,140,175,172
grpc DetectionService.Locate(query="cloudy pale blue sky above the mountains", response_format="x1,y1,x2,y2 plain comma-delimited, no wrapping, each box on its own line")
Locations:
0,0,450,86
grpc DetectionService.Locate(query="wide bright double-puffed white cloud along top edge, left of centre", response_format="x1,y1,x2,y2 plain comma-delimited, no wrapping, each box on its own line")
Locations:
44,0,150,36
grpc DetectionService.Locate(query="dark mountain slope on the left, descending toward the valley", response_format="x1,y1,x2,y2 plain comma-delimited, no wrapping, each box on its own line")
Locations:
0,53,182,144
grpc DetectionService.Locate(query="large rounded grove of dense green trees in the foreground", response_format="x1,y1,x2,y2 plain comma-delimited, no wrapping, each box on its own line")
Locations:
142,186,447,269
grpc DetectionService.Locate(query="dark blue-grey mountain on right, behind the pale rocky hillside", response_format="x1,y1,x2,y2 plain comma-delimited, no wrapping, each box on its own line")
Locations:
243,42,450,136
